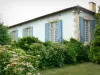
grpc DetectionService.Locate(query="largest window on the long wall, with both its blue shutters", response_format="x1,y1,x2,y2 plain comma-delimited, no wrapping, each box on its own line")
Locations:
45,20,62,43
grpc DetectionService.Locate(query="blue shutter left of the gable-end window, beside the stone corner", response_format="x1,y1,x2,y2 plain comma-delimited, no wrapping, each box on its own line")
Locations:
79,17,84,43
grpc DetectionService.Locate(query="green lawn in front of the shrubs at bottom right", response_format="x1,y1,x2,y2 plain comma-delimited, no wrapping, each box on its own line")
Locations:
40,63,100,75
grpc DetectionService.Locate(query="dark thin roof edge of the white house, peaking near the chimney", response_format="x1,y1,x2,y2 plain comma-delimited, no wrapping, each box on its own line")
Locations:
9,5,95,29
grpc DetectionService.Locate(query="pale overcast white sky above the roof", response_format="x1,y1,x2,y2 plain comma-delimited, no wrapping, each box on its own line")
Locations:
0,0,100,26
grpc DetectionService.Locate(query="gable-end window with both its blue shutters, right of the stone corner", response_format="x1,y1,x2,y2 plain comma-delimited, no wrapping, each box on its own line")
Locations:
79,17,96,43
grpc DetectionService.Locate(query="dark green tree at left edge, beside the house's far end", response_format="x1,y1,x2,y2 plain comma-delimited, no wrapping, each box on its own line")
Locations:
0,23,11,45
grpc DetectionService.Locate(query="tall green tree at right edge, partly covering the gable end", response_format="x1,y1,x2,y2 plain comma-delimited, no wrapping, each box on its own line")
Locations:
89,13,100,64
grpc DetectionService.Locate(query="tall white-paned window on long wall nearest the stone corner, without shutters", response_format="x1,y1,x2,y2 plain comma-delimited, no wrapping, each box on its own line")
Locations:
49,21,58,42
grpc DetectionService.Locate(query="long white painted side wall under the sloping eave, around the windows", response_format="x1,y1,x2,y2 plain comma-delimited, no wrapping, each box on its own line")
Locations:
9,10,74,41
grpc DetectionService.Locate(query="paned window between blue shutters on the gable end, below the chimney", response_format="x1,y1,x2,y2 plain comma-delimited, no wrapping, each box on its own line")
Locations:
84,20,89,42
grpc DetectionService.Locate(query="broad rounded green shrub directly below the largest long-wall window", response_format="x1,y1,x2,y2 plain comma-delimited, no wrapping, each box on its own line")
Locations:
47,43,65,67
